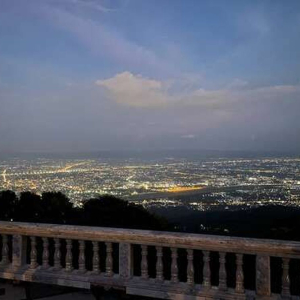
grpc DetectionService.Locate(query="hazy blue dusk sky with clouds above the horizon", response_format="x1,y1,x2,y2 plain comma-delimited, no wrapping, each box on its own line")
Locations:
0,0,300,152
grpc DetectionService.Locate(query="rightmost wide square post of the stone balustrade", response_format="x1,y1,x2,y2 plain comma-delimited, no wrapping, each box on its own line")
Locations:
256,255,271,297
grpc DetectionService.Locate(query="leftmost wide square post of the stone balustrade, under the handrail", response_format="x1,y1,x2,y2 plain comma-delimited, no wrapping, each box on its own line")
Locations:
12,235,27,269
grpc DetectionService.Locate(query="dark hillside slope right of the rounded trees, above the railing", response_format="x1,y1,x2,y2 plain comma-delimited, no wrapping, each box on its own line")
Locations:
151,205,300,241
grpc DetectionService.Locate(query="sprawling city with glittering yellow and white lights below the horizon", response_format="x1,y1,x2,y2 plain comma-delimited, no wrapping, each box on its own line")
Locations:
0,157,300,211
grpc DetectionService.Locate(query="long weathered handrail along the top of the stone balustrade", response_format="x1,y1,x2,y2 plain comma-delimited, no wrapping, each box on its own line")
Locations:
0,221,300,258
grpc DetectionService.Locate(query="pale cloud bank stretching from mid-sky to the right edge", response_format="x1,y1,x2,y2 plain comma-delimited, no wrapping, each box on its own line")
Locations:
96,72,300,109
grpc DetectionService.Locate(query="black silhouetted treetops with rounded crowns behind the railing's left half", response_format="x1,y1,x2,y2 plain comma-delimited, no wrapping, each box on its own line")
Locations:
0,191,169,230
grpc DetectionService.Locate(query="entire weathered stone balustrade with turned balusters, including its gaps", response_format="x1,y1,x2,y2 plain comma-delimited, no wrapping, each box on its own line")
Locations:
0,222,300,300
